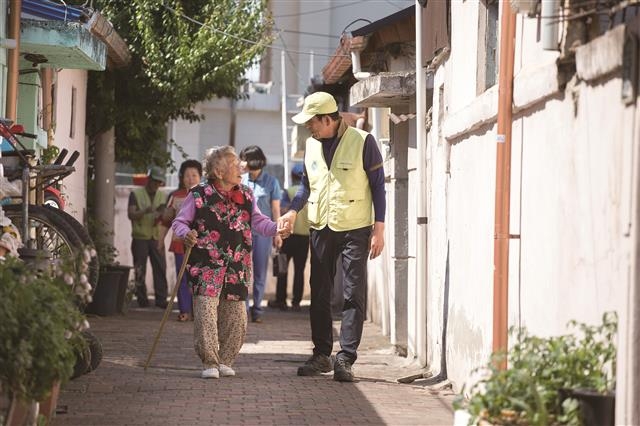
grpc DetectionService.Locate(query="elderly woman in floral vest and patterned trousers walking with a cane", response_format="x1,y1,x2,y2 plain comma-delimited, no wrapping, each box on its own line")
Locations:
172,146,289,379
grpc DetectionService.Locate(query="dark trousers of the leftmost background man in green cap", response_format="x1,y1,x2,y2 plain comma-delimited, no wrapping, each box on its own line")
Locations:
131,238,167,303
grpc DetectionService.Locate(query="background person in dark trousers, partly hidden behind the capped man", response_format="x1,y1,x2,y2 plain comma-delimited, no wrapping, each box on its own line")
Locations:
269,163,309,312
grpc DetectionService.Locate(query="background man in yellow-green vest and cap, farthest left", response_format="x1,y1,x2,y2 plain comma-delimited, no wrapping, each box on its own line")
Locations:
127,167,167,309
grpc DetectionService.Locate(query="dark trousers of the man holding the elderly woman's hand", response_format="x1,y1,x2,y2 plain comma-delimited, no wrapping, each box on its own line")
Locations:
310,227,371,363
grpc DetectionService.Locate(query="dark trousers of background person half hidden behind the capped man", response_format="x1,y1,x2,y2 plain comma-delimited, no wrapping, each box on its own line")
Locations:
276,234,309,305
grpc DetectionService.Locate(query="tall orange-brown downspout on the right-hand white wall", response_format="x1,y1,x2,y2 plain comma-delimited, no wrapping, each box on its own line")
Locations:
493,1,516,369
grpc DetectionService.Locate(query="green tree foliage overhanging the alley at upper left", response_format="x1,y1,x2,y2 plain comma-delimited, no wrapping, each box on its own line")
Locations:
87,0,271,169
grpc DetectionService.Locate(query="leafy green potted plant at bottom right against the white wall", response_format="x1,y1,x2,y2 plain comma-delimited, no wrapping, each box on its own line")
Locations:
454,312,618,425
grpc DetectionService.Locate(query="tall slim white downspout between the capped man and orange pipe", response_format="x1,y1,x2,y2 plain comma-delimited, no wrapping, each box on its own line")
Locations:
409,0,428,365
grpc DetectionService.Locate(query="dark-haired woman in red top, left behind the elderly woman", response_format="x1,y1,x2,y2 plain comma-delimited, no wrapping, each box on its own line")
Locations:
162,160,202,322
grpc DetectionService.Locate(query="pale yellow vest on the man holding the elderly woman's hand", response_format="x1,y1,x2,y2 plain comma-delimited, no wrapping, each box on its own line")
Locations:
304,126,374,231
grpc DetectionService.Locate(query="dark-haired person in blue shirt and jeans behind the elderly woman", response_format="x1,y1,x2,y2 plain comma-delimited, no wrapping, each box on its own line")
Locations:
240,145,282,323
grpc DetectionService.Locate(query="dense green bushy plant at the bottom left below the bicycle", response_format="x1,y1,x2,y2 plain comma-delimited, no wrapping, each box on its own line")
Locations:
0,258,88,401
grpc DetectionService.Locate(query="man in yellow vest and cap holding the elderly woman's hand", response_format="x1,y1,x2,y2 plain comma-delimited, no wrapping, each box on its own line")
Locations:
278,92,386,382
